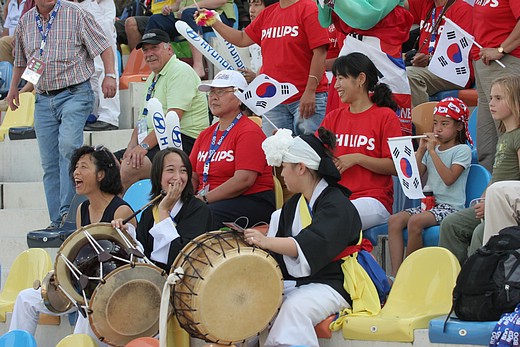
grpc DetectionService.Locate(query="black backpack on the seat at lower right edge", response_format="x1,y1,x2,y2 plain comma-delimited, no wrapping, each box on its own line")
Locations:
452,226,520,321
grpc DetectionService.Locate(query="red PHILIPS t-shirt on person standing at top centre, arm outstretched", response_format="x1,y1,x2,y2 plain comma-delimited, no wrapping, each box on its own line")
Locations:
245,0,329,104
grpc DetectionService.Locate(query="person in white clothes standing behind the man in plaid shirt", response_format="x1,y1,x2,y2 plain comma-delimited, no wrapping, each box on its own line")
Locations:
76,0,120,131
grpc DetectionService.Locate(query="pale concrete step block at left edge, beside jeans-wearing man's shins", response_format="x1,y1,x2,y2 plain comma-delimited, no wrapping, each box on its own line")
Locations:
0,182,47,210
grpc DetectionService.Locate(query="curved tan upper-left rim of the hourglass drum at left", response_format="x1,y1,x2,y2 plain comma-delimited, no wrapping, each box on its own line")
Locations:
54,223,136,305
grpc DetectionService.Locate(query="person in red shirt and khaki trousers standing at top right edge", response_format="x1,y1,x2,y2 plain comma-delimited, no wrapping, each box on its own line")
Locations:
473,0,520,171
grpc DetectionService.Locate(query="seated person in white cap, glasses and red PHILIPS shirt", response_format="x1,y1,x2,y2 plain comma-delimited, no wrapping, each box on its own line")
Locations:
190,70,275,229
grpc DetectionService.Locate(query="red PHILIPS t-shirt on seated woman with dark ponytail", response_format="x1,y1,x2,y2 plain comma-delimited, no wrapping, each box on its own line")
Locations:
321,105,401,213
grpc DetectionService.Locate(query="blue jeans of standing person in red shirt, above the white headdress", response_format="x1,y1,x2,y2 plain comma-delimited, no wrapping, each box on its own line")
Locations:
262,92,328,136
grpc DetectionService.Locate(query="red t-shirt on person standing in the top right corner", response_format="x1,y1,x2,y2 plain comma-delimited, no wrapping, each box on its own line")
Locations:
473,0,520,59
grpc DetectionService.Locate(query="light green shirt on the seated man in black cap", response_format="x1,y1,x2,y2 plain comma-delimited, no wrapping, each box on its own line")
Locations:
139,55,209,139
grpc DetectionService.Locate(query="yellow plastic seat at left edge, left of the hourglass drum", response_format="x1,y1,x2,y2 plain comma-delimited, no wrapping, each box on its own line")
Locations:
0,248,52,322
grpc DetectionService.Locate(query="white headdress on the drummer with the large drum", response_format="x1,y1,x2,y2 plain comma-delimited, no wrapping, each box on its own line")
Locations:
262,129,321,170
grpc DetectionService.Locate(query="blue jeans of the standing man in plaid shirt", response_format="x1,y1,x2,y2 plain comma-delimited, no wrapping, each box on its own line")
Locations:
34,81,94,226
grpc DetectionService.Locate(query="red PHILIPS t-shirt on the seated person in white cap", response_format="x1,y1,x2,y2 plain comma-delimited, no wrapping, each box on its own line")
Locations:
190,116,273,195
